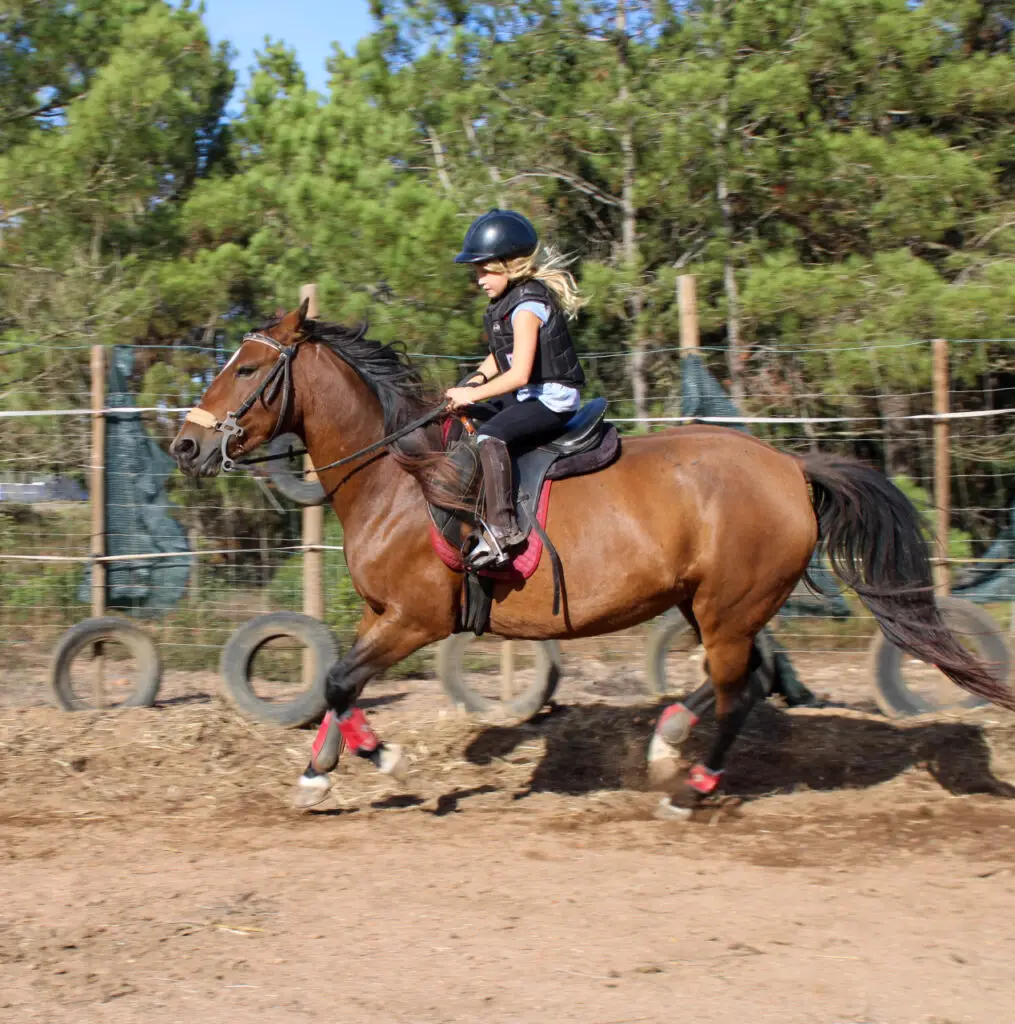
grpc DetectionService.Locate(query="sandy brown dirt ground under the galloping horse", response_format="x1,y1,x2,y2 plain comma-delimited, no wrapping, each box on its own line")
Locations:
0,654,1015,1024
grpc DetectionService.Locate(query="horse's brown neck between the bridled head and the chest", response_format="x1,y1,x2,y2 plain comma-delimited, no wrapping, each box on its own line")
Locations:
297,352,423,538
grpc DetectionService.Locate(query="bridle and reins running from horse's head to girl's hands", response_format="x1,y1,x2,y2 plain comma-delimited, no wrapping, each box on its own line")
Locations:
184,331,449,474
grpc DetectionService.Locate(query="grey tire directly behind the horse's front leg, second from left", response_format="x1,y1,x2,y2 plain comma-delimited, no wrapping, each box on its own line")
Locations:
219,611,339,729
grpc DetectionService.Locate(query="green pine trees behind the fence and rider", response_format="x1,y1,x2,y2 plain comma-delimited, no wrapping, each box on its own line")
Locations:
0,0,1015,618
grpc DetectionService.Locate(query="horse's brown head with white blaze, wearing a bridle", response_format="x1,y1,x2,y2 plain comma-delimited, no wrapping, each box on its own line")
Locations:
169,301,308,476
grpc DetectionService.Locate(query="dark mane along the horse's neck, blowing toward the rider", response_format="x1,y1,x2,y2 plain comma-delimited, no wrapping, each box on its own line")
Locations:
286,319,468,508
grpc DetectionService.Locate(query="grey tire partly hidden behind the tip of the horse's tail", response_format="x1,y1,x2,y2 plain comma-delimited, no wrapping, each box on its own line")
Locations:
868,597,1012,718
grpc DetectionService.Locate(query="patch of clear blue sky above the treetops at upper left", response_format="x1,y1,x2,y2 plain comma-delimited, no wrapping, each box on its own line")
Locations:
198,0,374,92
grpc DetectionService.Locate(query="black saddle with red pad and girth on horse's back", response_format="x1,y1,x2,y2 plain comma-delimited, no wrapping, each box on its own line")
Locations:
429,398,621,633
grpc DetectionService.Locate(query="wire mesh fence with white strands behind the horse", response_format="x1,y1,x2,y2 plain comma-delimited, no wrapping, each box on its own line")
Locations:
0,340,1015,696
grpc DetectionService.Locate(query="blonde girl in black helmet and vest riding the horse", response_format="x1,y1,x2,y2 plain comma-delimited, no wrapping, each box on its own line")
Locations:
446,209,585,564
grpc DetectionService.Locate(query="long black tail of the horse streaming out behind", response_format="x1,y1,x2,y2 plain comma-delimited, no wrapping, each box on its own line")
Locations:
800,454,1015,711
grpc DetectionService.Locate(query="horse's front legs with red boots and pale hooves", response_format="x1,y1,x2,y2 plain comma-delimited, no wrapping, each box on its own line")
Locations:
293,611,440,808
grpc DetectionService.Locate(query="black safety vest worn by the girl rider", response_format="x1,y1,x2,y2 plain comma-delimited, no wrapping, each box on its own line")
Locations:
482,281,585,387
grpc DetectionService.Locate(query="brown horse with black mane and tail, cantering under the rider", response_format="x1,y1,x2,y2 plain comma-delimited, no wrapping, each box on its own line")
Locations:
170,303,1015,808
